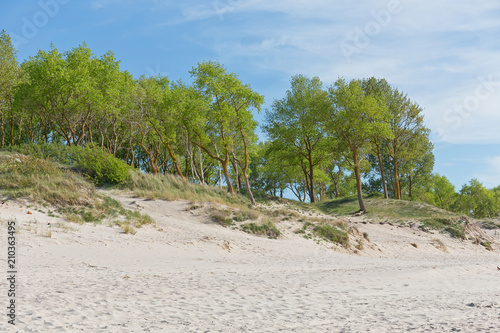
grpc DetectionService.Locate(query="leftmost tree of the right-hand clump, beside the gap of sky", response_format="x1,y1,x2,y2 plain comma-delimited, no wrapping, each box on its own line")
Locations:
264,75,329,202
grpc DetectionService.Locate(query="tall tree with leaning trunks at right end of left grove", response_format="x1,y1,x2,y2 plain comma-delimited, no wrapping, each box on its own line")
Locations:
190,61,264,204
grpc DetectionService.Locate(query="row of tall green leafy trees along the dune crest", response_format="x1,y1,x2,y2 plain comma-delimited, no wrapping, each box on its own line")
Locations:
0,31,498,218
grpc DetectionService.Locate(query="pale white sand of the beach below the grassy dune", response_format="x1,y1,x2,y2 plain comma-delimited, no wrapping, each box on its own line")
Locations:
0,193,500,332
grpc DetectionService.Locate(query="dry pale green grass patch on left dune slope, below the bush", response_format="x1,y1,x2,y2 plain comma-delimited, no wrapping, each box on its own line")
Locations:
0,152,154,228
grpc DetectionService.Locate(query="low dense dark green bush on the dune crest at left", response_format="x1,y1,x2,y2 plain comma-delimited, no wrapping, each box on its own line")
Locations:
7,144,132,186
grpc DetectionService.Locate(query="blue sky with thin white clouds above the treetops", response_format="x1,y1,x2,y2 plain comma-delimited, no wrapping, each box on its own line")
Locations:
0,0,500,189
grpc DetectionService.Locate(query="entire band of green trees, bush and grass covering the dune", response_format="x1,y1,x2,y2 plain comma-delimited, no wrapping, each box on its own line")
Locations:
0,31,500,238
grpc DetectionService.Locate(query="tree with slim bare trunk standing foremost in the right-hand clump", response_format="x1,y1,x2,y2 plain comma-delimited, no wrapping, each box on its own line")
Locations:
326,79,391,212
